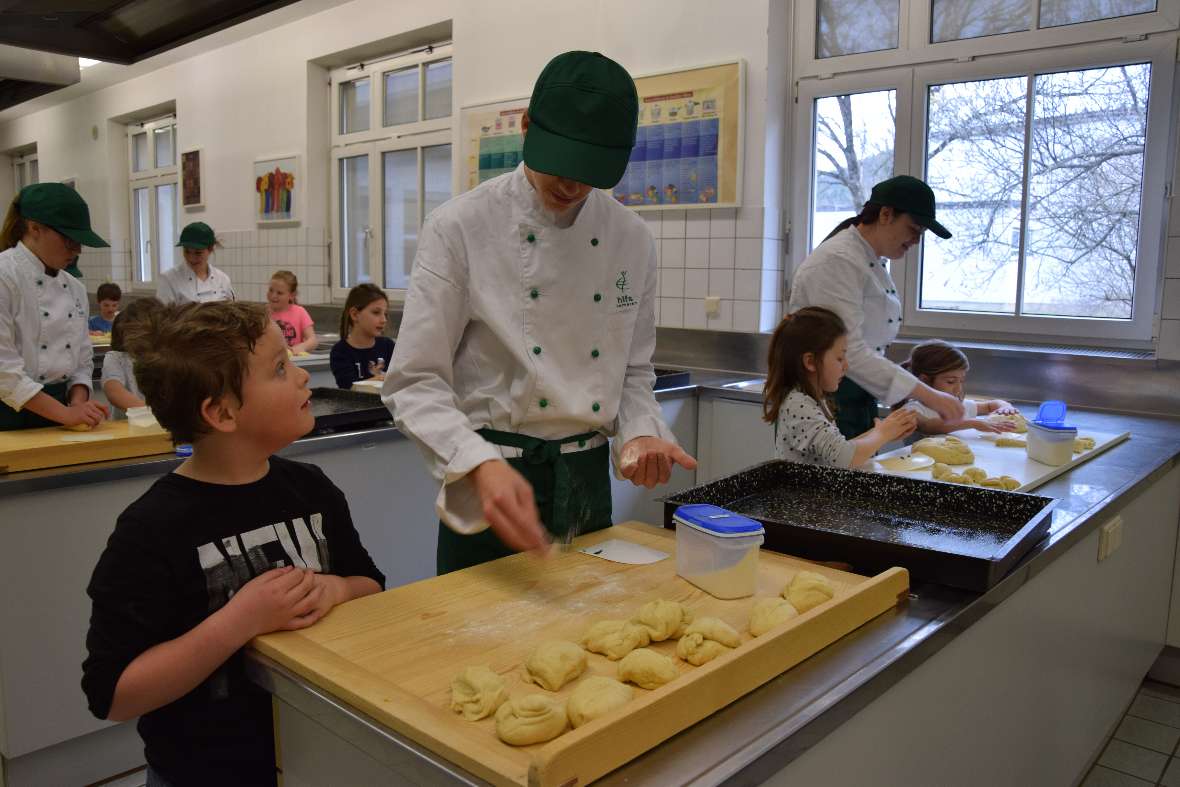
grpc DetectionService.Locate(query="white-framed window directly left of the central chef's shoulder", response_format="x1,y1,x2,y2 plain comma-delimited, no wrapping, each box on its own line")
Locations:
332,46,452,300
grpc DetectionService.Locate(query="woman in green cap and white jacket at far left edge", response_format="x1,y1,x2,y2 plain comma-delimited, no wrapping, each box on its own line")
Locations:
0,183,109,429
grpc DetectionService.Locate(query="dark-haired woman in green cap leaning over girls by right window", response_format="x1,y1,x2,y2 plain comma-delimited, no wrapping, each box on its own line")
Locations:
788,175,963,439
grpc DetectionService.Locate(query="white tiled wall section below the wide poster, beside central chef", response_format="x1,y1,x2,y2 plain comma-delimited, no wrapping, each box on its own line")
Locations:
641,206,785,332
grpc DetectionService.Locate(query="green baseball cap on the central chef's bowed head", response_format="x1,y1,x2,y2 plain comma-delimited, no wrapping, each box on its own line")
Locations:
524,52,640,189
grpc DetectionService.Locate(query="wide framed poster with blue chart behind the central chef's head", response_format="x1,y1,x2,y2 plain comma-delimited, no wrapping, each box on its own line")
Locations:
460,60,745,210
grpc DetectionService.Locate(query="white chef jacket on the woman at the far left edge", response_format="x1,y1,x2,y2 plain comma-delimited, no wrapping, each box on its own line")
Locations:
0,243,94,411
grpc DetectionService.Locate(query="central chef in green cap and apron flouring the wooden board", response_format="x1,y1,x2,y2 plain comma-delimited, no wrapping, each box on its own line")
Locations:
382,52,696,573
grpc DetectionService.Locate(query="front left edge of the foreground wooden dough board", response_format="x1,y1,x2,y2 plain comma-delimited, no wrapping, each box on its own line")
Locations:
250,631,529,787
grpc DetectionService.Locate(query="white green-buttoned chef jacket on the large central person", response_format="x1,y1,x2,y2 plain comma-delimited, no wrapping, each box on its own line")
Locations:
381,165,675,533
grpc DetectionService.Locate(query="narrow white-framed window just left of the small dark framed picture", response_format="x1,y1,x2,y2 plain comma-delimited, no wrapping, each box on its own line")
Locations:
127,117,181,289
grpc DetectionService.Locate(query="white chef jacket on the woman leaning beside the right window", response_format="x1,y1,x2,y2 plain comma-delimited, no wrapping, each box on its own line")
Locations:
788,227,918,405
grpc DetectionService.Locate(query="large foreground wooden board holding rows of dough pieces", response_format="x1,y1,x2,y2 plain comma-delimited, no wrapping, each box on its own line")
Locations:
253,523,909,787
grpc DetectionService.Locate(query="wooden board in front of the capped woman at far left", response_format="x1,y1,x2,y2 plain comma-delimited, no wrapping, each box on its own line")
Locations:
0,421,172,473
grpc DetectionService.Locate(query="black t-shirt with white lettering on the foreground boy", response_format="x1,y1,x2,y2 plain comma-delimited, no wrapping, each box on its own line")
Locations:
81,457,385,787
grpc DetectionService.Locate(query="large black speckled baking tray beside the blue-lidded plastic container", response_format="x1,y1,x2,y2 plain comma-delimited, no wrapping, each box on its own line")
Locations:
664,461,1056,592
